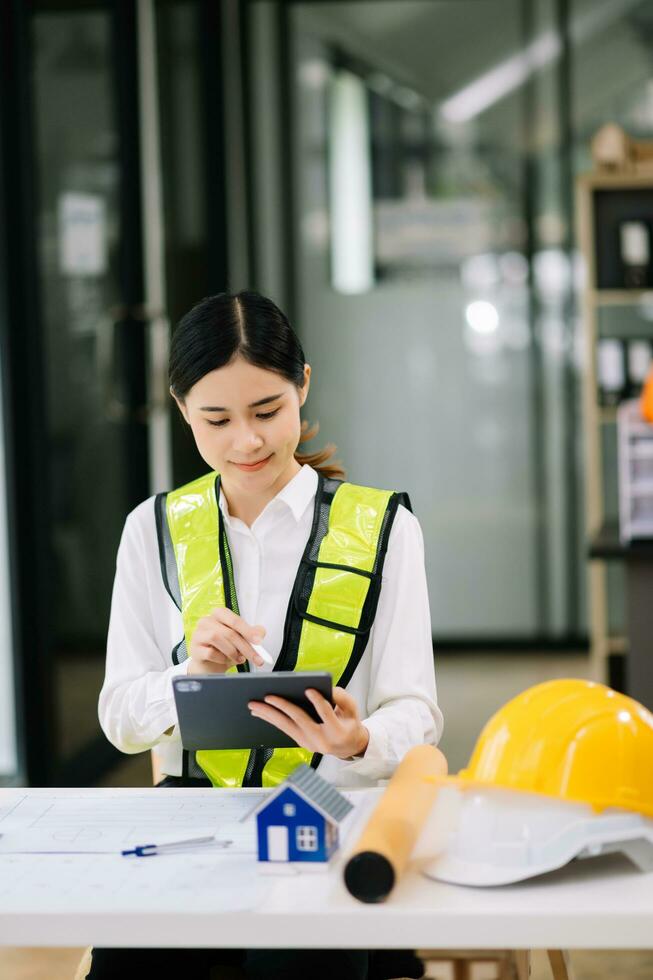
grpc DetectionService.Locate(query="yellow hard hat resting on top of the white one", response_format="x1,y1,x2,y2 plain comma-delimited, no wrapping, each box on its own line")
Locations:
453,680,653,817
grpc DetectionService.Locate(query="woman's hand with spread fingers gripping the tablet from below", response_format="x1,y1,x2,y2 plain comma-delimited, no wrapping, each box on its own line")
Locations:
248,687,370,759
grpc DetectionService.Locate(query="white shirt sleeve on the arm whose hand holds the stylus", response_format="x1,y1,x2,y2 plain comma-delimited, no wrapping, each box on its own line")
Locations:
98,501,188,753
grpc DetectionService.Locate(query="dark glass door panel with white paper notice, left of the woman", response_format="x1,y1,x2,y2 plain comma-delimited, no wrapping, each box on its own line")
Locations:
27,2,151,782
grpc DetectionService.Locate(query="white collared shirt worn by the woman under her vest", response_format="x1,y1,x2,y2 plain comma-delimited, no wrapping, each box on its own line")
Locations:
99,466,442,786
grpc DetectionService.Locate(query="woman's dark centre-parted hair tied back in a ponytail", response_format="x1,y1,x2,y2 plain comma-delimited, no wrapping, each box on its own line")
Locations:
169,290,345,479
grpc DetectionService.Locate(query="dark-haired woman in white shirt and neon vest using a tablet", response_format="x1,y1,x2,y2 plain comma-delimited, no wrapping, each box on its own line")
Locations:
95,292,442,977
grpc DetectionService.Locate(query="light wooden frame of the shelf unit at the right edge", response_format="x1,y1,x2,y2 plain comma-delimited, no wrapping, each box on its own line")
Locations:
576,171,653,682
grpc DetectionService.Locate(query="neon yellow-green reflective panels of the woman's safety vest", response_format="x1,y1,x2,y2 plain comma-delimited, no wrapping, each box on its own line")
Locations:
160,473,401,788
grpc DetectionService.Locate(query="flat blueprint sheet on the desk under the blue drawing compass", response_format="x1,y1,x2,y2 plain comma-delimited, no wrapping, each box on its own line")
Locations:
0,789,270,922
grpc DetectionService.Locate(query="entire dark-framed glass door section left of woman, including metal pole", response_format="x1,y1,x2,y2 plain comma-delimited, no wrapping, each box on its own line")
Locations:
0,0,229,785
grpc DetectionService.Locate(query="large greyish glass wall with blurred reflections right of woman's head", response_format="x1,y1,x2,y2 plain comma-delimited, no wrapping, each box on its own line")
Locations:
254,0,584,641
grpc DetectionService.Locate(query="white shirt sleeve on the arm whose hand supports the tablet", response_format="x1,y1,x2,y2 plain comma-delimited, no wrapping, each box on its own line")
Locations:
348,507,443,780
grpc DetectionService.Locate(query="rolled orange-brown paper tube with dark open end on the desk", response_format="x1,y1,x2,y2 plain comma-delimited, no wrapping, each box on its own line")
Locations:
345,745,447,902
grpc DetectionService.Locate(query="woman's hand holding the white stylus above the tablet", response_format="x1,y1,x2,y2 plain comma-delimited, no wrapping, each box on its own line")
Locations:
188,607,265,674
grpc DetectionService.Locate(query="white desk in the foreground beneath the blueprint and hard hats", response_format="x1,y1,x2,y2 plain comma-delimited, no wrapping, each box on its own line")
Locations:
0,789,653,949
